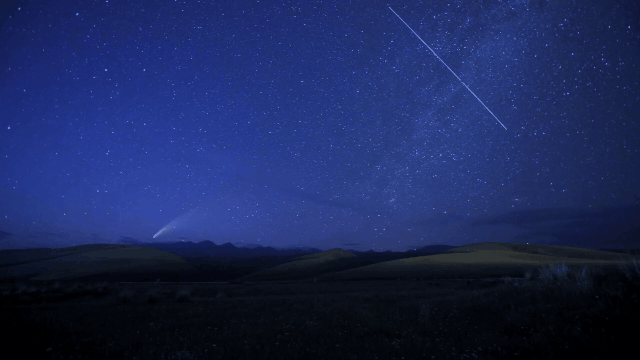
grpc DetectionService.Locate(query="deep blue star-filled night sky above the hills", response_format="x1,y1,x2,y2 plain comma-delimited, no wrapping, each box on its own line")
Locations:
0,0,640,251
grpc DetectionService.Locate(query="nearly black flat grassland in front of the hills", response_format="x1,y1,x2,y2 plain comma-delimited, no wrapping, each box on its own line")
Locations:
0,265,640,359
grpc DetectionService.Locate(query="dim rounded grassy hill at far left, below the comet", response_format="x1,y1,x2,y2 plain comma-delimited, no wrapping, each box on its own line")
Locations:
0,244,194,280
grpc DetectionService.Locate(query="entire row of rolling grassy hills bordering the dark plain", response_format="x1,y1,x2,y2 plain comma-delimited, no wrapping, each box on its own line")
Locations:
0,243,638,282
